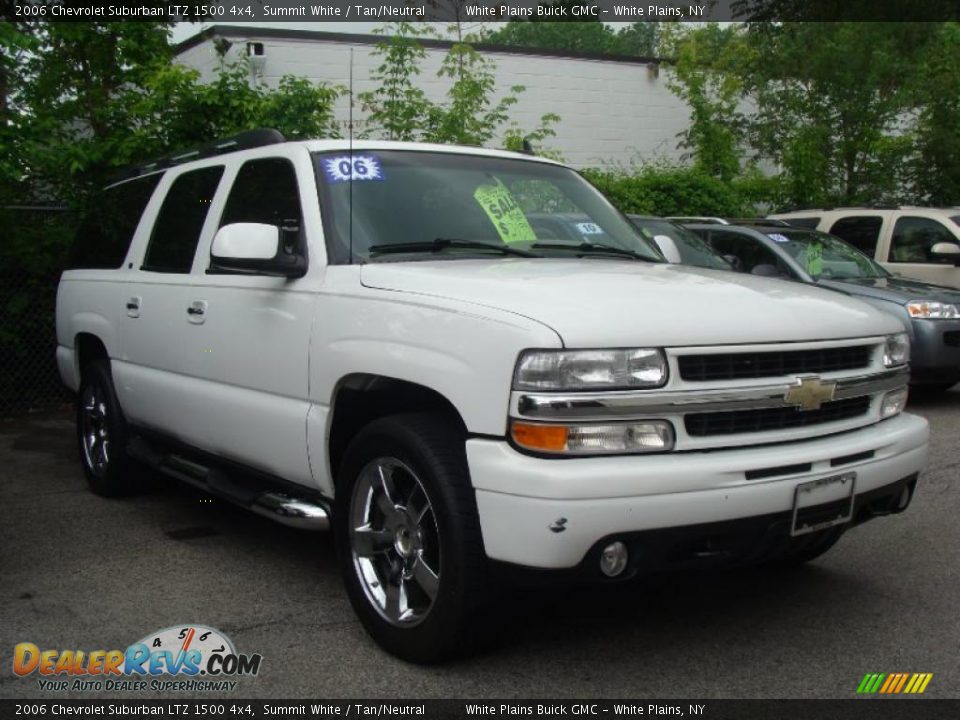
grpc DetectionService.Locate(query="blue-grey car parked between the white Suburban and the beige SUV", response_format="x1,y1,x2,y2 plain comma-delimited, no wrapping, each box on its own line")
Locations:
688,225,960,390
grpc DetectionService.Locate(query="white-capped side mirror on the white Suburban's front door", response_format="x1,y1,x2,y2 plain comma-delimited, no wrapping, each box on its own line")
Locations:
207,223,307,278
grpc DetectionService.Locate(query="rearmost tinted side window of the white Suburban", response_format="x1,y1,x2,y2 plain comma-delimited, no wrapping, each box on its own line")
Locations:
67,173,163,269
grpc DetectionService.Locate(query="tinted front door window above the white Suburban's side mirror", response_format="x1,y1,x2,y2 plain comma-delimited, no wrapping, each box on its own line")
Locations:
220,158,301,227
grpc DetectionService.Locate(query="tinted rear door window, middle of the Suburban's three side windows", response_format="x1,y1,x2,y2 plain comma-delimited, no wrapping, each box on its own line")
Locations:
142,165,223,273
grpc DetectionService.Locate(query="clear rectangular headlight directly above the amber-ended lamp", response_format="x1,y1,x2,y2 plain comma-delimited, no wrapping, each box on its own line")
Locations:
513,348,667,390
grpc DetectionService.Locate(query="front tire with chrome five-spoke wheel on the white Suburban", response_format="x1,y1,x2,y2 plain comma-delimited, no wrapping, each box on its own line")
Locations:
334,414,486,663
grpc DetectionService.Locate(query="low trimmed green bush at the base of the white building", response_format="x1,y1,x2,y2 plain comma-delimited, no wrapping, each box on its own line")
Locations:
584,167,752,217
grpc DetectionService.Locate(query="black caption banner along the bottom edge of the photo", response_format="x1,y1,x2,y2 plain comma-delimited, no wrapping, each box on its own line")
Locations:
0,695,960,720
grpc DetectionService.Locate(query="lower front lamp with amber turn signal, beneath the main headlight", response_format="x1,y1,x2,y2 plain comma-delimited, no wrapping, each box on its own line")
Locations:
510,420,674,455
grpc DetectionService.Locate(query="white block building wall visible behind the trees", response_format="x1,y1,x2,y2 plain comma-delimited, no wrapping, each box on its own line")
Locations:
179,28,689,167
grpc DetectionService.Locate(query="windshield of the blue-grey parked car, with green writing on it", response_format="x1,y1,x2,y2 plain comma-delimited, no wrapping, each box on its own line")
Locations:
766,228,890,280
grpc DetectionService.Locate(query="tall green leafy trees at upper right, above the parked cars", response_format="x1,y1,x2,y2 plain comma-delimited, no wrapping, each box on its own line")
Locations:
668,22,960,207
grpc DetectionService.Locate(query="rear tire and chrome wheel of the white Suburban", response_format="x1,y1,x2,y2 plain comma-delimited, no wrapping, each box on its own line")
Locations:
77,360,139,497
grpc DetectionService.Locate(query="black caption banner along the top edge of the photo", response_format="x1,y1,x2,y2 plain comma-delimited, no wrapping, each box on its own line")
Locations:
4,0,960,24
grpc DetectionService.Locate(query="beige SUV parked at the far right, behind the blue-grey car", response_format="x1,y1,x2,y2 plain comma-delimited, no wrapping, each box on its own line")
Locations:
770,206,960,288
